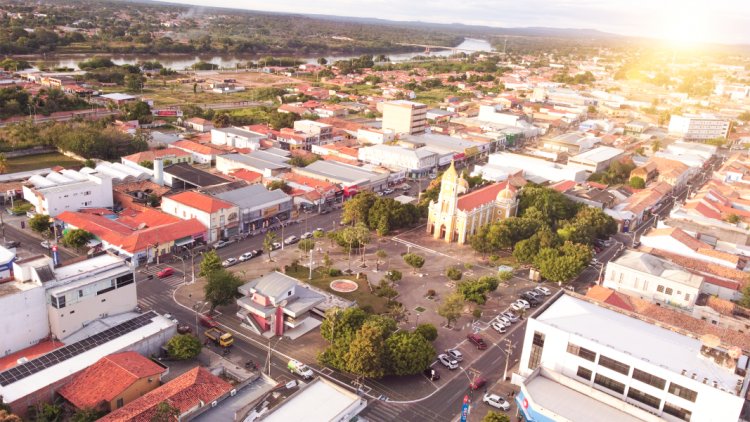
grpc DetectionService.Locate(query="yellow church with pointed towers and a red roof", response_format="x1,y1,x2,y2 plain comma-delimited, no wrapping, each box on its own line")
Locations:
427,163,518,243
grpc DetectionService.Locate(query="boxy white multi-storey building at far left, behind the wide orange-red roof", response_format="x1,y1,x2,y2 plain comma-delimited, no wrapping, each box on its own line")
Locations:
23,167,114,217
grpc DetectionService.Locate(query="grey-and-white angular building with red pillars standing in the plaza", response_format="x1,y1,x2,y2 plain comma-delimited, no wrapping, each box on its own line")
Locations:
237,272,326,336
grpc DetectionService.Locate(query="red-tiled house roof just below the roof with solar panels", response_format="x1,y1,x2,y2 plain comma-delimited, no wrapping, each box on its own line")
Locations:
58,352,166,409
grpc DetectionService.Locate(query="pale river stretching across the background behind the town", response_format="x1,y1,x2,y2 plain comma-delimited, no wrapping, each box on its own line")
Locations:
32,38,492,70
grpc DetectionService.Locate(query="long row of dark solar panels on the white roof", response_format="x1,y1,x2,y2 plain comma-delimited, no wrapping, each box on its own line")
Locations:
0,311,157,387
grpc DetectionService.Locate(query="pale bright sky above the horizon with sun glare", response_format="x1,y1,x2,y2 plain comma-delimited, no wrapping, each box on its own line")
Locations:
164,0,750,44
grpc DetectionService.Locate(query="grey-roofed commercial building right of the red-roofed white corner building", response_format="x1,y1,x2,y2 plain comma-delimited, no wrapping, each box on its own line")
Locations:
202,181,294,233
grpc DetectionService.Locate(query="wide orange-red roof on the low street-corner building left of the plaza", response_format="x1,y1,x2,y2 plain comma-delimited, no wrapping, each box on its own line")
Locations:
56,210,206,253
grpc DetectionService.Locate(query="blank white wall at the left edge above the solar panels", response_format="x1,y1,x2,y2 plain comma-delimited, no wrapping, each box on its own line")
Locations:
0,283,49,356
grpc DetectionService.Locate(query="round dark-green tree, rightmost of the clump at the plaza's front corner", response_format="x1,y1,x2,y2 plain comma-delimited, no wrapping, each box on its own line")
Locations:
385,327,435,375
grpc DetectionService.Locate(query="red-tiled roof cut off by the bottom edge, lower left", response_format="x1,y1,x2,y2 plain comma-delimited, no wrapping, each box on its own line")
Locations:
99,367,233,422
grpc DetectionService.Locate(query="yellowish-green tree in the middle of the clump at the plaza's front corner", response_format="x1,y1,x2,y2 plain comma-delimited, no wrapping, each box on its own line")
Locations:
345,321,390,378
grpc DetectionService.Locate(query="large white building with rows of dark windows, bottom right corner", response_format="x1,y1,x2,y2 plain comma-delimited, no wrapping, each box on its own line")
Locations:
513,294,748,421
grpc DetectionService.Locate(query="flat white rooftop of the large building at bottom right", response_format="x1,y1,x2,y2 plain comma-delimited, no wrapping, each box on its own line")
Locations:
535,294,743,391
